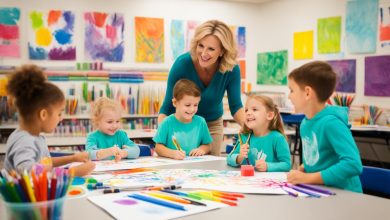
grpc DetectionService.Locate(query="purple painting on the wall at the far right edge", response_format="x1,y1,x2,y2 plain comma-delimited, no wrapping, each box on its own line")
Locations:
364,55,390,97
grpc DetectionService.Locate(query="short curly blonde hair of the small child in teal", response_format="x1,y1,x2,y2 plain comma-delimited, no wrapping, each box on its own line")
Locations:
91,97,122,128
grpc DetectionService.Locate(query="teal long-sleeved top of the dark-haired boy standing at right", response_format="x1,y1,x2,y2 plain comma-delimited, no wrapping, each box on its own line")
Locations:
300,106,363,192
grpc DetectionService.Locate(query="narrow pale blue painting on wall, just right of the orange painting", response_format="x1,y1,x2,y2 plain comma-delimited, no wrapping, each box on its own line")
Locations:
170,20,185,60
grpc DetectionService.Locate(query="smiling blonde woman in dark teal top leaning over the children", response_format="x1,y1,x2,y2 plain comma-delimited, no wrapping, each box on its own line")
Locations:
158,20,244,156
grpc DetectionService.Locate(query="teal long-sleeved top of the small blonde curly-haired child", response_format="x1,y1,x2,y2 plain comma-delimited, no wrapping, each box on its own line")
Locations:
85,130,140,160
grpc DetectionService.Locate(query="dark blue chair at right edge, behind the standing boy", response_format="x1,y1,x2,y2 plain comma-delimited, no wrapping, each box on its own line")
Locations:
360,166,390,198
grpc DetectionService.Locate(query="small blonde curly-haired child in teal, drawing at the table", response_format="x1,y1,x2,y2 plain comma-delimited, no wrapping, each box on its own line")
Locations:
85,97,140,161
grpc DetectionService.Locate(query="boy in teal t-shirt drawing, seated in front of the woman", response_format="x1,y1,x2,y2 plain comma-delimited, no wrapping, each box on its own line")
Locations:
153,79,212,160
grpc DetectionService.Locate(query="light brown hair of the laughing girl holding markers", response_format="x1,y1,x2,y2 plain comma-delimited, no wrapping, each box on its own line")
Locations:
242,95,286,137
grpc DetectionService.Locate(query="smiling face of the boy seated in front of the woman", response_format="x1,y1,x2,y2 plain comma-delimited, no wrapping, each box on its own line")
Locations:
173,95,200,122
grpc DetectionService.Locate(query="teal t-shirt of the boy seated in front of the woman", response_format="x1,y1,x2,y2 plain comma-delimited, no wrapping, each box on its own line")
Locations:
153,114,213,156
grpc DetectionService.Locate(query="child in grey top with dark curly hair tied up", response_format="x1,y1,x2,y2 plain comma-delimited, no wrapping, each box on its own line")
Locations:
4,65,95,176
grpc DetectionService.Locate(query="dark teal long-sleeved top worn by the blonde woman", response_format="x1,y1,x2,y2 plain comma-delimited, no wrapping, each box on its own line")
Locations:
160,53,243,121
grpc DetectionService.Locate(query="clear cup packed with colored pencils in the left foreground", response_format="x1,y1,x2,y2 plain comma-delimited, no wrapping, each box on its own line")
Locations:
0,166,73,220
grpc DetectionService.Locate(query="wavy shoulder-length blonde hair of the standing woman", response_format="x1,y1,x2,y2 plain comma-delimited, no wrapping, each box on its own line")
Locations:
190,20,238,73
